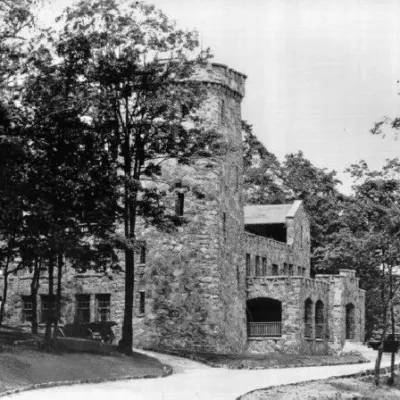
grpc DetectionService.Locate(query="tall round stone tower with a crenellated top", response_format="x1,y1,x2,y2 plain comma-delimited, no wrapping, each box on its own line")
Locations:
134,64,246,352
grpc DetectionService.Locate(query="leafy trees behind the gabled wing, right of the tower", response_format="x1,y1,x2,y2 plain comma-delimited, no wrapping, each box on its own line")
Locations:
242,126,346,273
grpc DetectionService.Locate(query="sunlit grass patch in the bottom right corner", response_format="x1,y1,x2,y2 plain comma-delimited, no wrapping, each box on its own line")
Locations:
241,376,400,400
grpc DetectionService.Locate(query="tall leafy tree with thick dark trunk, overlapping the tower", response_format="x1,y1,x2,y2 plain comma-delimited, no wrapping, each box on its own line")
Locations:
58,0,223,353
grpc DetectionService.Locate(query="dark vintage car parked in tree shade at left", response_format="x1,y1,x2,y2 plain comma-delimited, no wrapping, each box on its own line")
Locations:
59,321,117,344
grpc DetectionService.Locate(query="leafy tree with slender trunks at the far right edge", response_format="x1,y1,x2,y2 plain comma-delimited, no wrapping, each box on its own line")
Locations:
323,159,400,385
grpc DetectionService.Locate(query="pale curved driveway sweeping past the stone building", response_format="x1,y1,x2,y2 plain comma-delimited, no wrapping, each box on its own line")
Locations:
6,347,390,400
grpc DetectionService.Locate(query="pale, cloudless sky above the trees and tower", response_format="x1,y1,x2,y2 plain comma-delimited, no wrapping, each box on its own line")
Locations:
40,0,400,192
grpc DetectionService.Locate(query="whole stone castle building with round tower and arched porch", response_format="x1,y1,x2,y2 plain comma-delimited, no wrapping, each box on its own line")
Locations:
0,64,365,354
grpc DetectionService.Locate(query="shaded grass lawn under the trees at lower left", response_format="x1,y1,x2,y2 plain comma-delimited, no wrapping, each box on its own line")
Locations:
0,329,169,393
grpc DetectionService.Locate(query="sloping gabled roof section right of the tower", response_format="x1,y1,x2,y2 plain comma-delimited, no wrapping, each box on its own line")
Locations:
244,200,301,225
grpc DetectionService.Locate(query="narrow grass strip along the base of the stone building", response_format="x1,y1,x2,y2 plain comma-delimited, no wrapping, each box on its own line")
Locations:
156,351,368,369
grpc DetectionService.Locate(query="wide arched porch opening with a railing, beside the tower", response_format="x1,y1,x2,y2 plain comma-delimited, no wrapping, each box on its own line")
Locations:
247,297,282,336
